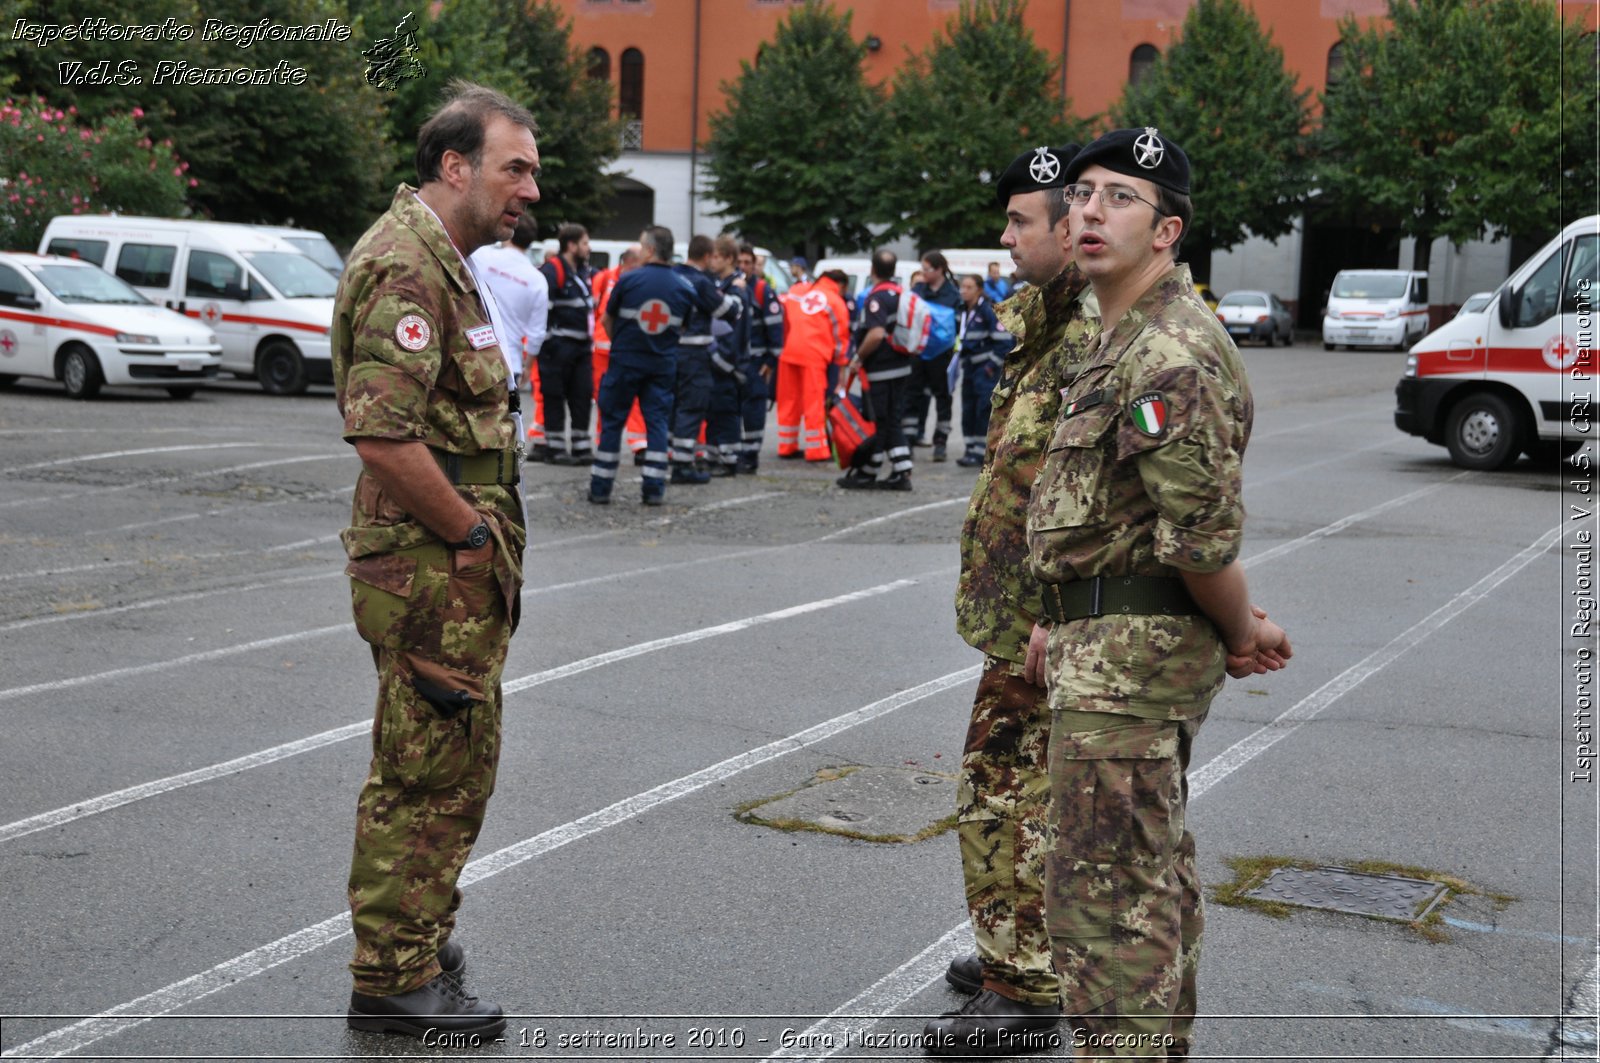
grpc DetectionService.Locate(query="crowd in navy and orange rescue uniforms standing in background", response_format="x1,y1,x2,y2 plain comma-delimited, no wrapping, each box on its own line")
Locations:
472,216,1014,501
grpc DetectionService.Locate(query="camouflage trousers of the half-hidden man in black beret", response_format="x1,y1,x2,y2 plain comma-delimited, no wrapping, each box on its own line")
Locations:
957,656,1061,1004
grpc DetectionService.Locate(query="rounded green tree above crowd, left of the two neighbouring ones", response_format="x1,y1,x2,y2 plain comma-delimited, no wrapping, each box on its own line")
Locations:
706,0,880,261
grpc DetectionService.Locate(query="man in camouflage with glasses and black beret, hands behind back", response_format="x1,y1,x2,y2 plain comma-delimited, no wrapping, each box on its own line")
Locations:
1027,128,1290,1058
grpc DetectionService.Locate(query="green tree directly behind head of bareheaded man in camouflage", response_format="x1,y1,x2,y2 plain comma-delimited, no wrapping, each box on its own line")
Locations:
362,0,622,235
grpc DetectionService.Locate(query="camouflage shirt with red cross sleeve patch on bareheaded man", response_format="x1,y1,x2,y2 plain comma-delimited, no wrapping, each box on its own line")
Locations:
331,184,522,559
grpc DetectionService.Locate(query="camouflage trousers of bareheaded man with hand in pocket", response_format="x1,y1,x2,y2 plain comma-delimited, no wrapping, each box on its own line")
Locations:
349,525,520,996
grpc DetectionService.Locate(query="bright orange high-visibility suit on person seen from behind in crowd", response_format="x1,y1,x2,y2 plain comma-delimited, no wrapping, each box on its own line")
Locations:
778,277,850,461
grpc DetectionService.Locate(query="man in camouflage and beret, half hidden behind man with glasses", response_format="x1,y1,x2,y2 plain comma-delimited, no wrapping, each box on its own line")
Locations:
926,144,1099,1055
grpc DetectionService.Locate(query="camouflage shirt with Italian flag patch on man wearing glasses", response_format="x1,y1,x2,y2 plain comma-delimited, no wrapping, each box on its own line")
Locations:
1027,266,1253,719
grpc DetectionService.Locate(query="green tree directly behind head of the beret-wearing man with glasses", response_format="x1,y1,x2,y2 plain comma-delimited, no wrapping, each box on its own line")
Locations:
1112,0,1310,277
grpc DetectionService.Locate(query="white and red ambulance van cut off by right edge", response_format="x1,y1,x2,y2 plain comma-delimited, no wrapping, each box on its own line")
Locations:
1395,215,1600,469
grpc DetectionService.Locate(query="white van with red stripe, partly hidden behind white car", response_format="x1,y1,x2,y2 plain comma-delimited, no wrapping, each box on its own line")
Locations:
38,215,338,395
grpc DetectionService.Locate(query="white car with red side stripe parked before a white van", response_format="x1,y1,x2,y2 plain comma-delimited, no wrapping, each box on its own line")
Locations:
0,251,222,399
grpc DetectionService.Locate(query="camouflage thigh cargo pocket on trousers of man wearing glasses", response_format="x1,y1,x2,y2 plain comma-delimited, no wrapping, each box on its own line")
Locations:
1050,714,1184,868
